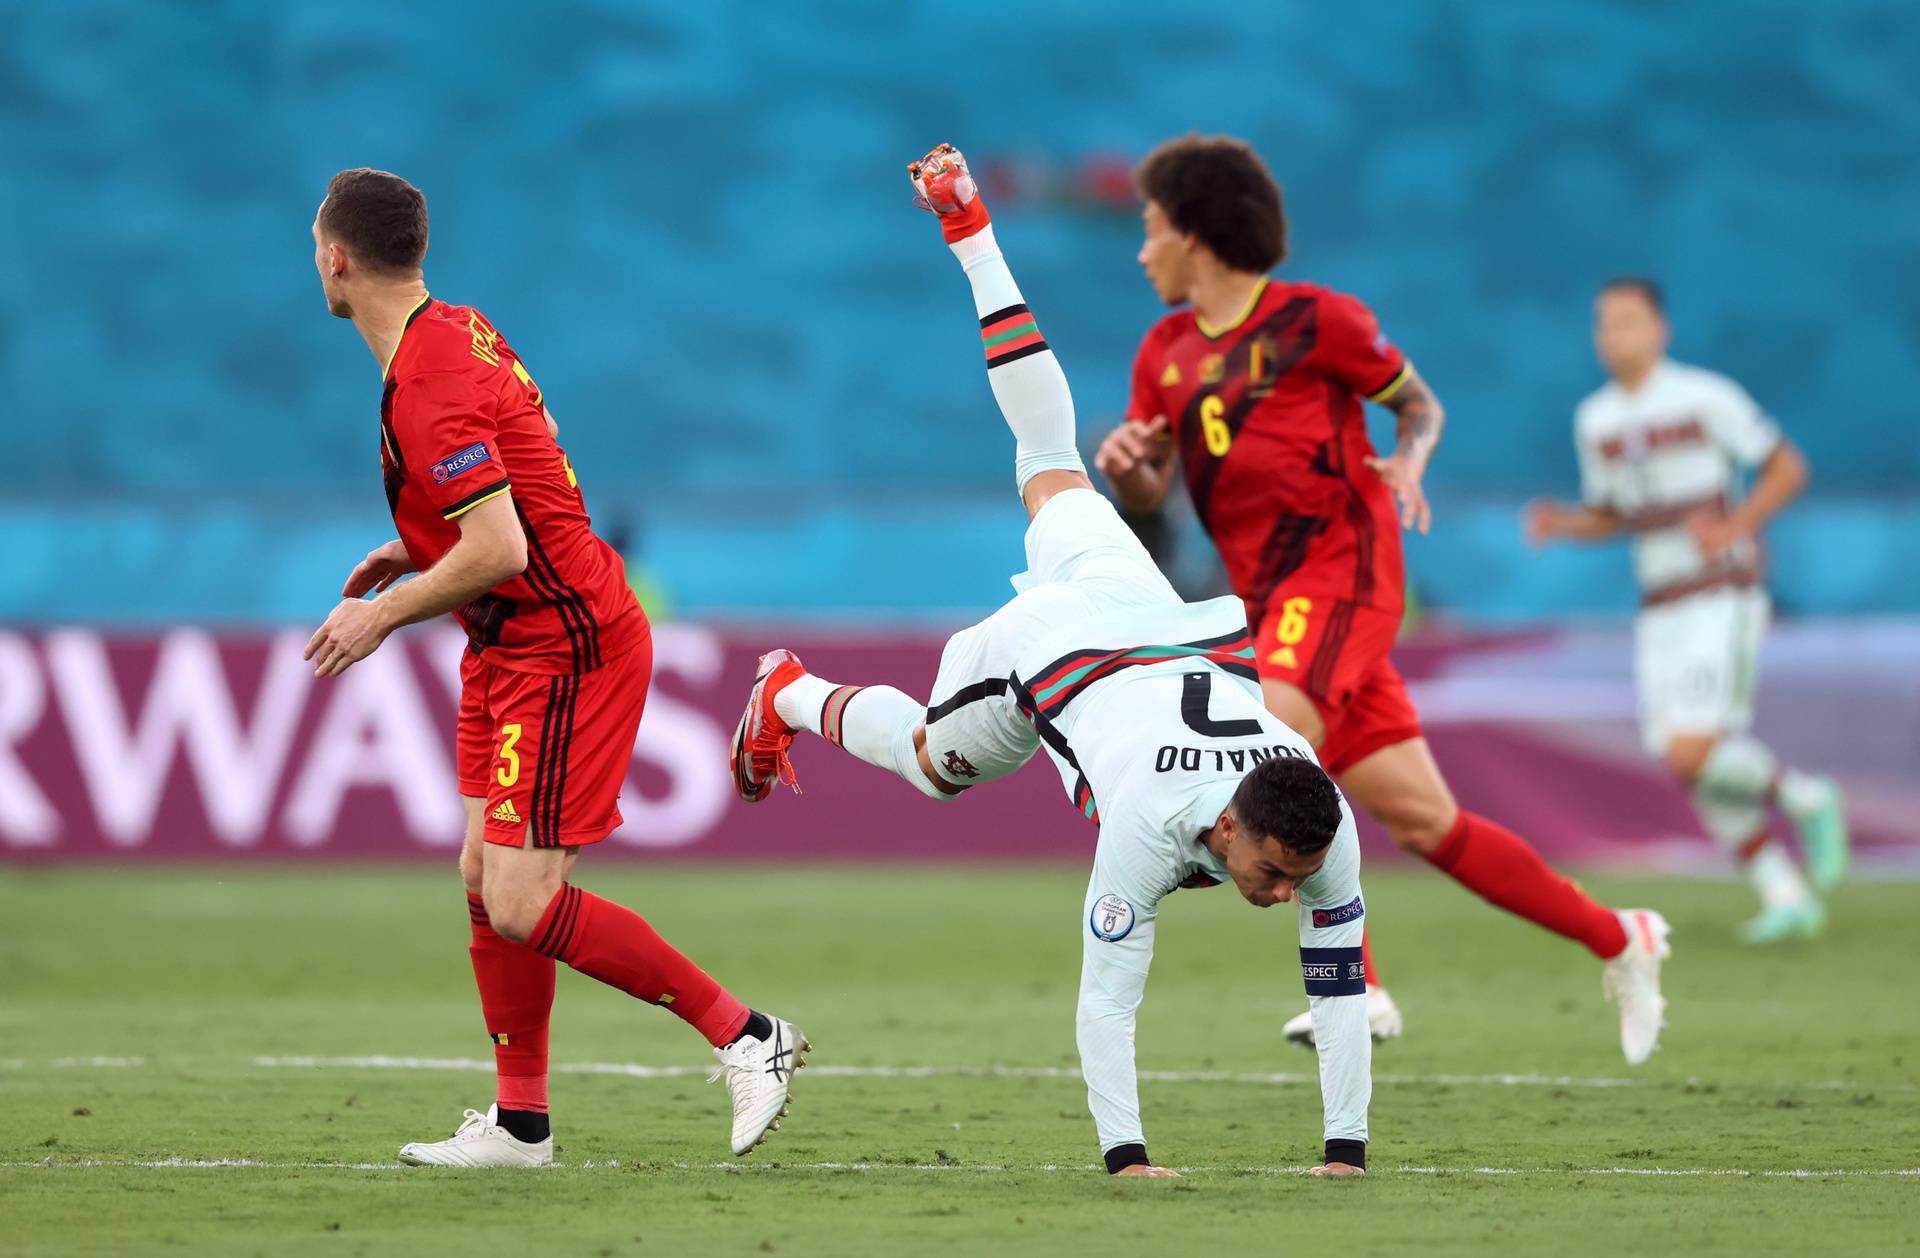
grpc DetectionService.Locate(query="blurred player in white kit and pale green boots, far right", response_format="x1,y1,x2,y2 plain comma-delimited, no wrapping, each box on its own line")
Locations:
1526,278,1847,943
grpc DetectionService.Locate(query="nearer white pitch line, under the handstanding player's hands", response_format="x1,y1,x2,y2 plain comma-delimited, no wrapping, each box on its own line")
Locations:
0,1158,1920,1179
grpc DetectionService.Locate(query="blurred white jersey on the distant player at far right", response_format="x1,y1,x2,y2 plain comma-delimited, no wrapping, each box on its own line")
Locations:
1574,359,1780,595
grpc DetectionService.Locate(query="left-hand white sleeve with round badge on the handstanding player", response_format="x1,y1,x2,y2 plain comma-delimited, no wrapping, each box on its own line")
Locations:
1075,826,1175,1170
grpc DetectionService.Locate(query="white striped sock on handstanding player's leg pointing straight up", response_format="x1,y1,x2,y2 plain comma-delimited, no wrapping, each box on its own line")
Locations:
950,225,1087,492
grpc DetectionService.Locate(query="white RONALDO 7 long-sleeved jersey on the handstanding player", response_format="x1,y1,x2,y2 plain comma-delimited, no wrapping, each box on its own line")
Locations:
1016,597,1373,1150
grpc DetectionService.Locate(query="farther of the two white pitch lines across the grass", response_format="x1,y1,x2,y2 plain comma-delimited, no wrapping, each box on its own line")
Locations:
253,1054,1920,1093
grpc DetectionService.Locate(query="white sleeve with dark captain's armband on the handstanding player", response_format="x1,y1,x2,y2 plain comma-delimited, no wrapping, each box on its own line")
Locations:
1300,803,1373,1156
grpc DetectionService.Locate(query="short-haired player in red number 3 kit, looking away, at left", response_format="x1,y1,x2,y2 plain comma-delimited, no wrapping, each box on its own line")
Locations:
307,169,808,1166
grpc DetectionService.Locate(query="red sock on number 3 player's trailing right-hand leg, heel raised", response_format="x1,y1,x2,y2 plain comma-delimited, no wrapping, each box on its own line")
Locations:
530,883,749,1049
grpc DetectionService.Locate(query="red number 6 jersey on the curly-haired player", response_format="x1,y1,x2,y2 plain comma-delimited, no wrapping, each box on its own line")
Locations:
1127,280,1409,620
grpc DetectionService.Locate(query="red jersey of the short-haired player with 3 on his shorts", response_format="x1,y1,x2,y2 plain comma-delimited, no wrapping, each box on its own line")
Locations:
380,298,651,674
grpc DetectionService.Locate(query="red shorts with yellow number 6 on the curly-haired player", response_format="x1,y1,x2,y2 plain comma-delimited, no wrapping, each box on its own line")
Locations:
1254,590,1421,776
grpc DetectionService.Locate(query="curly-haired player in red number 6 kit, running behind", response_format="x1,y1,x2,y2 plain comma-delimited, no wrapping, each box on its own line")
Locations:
1096,136,1667,1062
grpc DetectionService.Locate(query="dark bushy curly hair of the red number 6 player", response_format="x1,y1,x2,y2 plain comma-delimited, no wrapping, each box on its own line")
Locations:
1133,134,1286,271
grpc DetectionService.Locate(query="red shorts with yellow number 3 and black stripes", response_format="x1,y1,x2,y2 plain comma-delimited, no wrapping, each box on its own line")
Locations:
453,634,653,847
